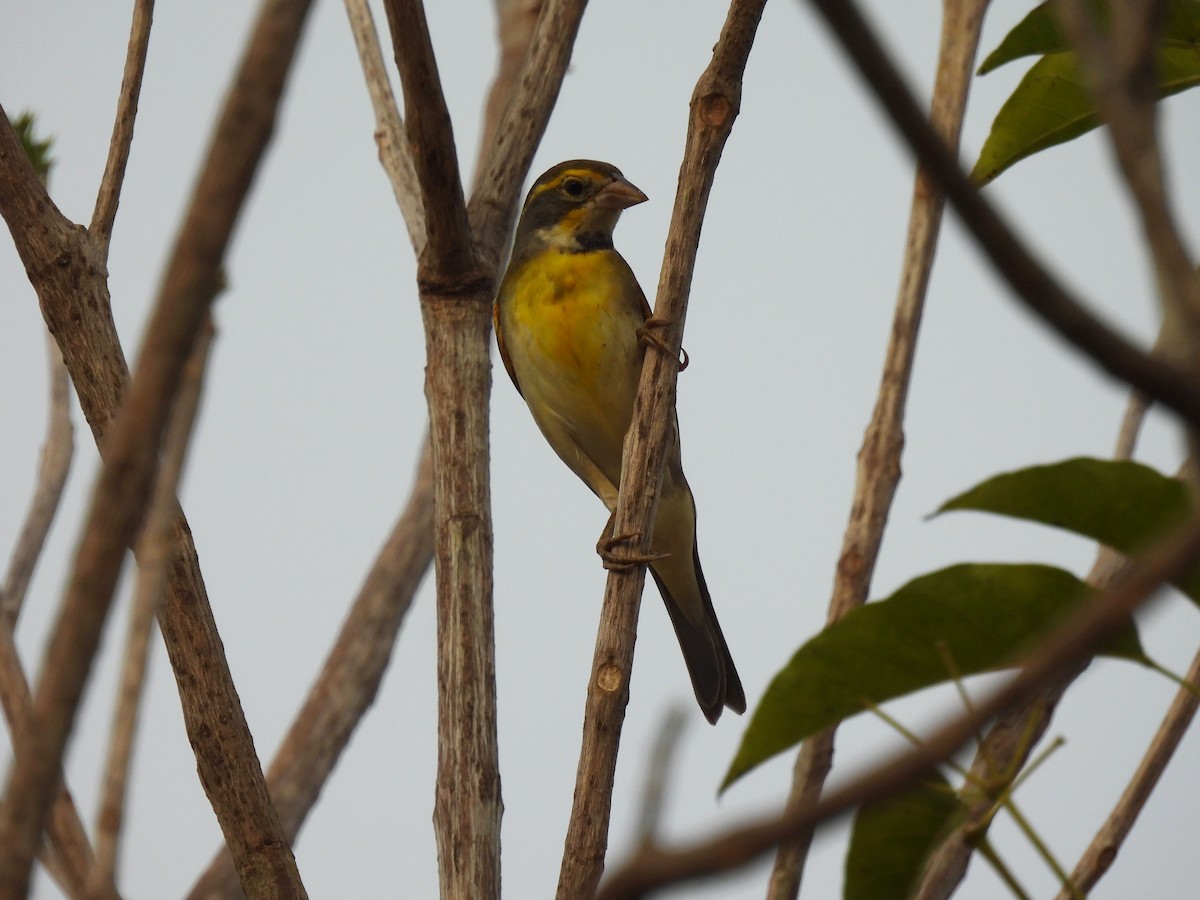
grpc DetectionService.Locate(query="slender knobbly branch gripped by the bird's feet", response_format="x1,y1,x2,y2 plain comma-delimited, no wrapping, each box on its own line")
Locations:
557,0,764,900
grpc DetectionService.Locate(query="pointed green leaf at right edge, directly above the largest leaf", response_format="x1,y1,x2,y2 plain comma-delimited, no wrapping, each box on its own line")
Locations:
938,457,1200,602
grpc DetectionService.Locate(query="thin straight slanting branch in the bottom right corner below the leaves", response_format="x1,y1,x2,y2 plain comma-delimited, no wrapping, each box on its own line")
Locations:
1058,654,1200,900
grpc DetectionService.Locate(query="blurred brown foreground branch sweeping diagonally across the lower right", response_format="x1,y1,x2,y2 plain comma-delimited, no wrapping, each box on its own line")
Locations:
596,517,1200,900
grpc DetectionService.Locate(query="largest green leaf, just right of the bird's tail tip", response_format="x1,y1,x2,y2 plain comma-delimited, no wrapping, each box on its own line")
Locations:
722,564,1148,790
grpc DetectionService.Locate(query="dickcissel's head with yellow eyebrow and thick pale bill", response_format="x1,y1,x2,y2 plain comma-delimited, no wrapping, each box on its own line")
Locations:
516,160,646,252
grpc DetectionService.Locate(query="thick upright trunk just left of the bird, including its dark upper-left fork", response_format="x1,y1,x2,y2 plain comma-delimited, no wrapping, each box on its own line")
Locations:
385,0,516,900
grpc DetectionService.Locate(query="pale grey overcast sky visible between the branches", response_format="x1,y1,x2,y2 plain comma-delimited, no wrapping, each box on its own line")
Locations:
0,0,1200,900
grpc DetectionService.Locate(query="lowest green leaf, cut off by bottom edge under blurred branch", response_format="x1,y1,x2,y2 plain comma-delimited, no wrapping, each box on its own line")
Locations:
844,772,962,900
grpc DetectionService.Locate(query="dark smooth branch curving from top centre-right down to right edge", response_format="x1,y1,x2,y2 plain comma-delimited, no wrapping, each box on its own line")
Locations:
810,0,1200,428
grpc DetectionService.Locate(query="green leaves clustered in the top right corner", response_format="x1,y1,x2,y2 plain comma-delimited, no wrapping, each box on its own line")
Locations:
971,0,1200,185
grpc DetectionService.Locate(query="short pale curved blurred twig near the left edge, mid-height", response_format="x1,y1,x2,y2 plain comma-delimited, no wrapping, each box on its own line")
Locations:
0,335,74,631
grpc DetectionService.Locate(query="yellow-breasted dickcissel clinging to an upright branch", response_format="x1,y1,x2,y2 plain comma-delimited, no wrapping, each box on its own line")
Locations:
494,160,746,722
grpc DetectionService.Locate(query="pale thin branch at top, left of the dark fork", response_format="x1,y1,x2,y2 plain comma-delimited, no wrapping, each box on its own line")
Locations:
346,0,425,250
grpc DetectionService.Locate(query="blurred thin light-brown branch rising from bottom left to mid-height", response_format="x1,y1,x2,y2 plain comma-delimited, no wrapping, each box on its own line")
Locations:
86,317,212,900
